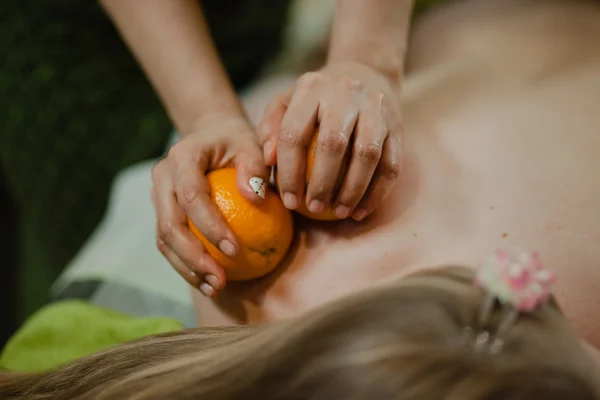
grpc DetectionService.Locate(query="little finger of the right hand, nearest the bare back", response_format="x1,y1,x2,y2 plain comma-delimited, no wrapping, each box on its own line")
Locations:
352,135,400,221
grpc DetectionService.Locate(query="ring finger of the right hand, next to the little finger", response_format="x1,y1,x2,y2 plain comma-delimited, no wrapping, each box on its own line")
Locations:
334,104,388,219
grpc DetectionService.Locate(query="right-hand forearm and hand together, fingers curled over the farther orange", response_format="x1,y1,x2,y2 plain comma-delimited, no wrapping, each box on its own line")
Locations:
258,0,414,221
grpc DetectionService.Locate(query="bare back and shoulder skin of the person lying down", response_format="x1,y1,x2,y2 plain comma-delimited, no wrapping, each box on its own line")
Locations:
193,0,600,356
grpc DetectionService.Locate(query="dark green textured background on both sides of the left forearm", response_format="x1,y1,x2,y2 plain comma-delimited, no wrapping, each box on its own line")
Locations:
0,0,289,320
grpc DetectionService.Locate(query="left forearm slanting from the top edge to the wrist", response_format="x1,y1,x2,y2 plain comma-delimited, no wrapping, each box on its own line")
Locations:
100,0,242,135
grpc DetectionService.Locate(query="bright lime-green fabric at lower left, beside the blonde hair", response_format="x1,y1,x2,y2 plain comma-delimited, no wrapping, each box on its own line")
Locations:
0,300,182,372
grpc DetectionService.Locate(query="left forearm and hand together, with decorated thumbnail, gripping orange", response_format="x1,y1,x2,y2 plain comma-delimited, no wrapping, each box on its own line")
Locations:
100,0,268,290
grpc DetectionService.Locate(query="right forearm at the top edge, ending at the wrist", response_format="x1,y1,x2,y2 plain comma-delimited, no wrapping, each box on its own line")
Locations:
328,0,414,82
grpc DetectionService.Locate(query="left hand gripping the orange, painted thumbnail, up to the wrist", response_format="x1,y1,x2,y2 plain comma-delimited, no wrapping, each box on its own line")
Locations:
152,116,269,297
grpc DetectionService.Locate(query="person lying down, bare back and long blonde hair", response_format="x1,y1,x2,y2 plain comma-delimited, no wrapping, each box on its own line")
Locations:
0,0,600,400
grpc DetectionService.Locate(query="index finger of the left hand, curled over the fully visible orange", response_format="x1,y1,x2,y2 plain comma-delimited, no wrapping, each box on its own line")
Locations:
171,152,237,257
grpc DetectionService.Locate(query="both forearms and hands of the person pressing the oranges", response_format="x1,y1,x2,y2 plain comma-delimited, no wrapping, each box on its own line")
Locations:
101,0,414,296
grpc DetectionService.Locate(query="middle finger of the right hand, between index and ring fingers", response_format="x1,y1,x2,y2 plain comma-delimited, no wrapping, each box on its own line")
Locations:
306,86,358,213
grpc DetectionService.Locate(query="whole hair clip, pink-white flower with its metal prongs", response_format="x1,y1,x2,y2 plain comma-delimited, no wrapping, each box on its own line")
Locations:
467,249,556,354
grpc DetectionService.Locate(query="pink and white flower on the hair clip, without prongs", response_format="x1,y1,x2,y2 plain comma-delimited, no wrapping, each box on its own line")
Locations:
475,249,556,312
